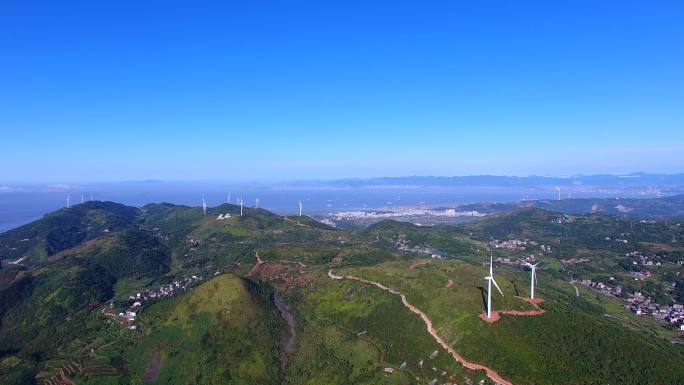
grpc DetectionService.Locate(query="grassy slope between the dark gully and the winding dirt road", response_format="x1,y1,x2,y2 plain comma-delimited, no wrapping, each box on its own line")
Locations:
285,270,483,384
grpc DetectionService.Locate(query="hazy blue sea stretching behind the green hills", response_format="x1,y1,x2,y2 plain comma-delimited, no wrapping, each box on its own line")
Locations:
0,182,640,233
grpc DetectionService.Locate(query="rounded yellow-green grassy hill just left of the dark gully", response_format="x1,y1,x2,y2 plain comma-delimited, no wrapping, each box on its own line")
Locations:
77,275,280,384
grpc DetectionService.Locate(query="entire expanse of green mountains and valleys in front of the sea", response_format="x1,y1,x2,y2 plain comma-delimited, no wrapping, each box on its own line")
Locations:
0,202,684,385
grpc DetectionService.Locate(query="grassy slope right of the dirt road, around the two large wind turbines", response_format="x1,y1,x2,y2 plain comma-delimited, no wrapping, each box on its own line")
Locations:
342,261,684,384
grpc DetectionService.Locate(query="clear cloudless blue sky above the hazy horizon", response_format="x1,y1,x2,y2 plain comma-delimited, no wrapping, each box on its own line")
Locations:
0,0,684,182
